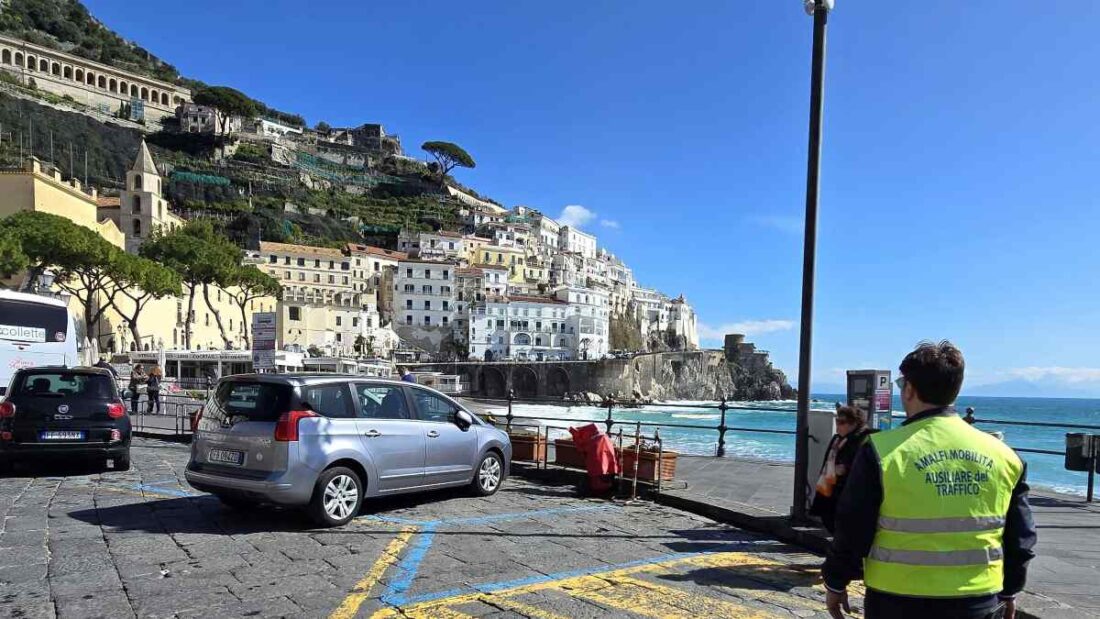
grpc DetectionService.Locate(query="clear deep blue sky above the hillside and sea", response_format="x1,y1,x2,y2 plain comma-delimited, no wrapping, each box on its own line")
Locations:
88,0,1100,395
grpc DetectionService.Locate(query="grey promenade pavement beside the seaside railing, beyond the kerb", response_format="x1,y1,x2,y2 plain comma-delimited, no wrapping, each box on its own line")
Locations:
667,456,1100,617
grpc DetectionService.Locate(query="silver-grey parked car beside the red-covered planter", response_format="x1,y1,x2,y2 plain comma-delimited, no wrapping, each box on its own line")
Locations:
186,374,512,527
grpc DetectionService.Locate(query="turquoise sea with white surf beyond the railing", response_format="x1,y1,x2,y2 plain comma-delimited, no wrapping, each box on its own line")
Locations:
483,394,1100,495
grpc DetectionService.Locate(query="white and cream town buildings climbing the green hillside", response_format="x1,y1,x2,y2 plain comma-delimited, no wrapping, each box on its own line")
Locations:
0,29,699,374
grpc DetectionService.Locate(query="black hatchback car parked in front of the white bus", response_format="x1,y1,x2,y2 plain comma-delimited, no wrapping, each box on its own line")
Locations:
0,367,130,471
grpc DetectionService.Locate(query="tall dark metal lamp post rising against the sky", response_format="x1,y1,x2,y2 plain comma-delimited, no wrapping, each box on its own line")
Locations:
791,0,833,520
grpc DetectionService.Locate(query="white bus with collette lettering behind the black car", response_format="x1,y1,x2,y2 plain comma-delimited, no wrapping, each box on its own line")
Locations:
0,290,79,397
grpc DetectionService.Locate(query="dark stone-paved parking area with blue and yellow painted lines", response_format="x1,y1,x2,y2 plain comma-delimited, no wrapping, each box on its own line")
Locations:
0,439,858,619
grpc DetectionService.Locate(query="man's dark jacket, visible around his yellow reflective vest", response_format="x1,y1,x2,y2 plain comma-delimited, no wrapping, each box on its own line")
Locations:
822,407,1036,618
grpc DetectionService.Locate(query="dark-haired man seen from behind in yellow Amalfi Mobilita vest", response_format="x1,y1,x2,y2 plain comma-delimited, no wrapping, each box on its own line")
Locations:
822,342,1036,619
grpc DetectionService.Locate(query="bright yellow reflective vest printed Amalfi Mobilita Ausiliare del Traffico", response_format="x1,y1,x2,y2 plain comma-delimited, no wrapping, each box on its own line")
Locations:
864,414,1023,597
